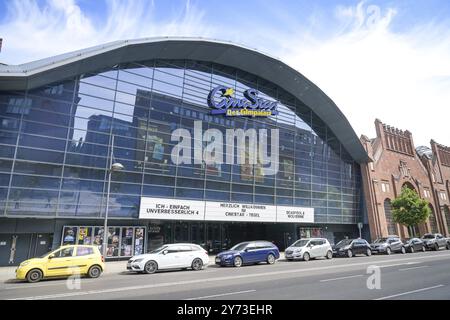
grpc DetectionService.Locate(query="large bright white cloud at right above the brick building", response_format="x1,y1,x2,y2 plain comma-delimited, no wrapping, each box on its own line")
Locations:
276,2,450,146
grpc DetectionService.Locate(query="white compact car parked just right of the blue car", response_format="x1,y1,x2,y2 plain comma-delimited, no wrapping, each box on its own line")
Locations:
284,238,333,261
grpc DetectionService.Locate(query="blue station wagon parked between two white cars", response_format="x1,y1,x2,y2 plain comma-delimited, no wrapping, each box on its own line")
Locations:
216,241,280,267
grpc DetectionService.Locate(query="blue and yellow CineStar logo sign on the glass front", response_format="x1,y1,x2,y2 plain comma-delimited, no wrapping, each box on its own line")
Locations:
208,86,278,117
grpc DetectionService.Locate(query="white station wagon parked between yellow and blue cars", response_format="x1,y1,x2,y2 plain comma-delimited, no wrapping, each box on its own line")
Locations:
127,243,209,273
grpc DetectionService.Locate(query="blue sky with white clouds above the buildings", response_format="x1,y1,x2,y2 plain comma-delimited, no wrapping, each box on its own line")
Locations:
0,0,450,146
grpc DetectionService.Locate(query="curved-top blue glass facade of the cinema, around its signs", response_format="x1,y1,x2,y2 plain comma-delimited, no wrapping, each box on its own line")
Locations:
0,60,362,225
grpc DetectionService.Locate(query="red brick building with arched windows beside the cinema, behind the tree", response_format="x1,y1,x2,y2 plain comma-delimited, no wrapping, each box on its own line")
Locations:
361,119,450,239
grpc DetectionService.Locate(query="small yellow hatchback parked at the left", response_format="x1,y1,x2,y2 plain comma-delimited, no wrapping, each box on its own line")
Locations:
16,245,105,282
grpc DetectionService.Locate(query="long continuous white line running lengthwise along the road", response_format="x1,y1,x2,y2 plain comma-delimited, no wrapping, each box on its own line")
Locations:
9,254,450,300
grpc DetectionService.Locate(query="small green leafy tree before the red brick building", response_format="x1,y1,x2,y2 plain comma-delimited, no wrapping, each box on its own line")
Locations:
391,187,431,234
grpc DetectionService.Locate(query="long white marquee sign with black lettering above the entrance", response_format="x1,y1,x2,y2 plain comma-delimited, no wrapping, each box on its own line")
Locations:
139,197,314,223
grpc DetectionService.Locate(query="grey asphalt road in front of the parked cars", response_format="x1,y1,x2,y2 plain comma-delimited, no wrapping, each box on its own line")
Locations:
0,251,450,300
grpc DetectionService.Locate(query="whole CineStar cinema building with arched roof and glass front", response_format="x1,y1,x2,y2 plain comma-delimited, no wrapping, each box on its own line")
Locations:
0,38,370,265
